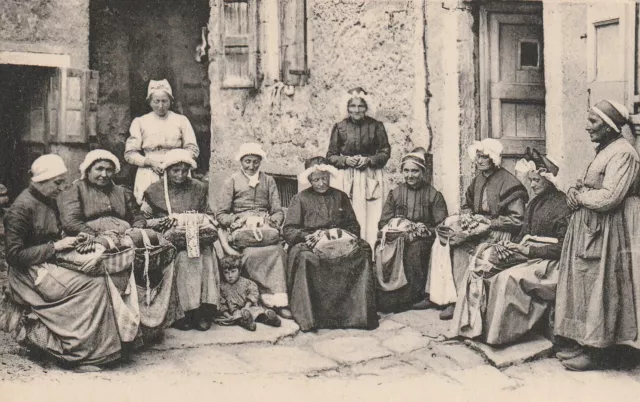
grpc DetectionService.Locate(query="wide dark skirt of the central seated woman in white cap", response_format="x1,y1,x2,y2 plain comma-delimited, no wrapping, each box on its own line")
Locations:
287,241,378,331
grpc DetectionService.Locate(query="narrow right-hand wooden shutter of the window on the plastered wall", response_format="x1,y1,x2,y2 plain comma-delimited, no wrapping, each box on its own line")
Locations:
280,0,309,85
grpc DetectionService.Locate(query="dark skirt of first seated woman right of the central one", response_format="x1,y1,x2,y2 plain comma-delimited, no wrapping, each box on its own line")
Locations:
377,239,433,312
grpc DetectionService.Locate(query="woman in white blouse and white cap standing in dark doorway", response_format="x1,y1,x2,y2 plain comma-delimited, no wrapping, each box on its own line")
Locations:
124,80,200,204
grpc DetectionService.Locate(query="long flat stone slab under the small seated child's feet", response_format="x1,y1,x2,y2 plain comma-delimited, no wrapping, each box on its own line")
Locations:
152,320,300,350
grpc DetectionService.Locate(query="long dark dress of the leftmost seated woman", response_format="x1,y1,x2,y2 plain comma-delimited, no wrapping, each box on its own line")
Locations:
4,187,121,364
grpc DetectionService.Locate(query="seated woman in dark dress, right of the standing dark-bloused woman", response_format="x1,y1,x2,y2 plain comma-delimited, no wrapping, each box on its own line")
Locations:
376,148,448,311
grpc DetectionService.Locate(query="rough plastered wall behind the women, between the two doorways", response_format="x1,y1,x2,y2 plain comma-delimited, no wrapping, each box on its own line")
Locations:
209,0,429,207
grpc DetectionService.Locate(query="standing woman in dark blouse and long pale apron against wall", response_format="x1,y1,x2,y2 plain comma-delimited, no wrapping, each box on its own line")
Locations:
327,87,391,249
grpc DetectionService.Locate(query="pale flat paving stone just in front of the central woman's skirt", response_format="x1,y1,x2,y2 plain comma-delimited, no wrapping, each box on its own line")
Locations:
313,336,392,364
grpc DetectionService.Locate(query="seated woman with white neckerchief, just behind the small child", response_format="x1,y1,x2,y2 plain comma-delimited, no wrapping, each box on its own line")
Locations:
216,143,292,319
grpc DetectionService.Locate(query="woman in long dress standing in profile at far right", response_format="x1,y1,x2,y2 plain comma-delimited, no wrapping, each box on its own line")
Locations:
555,100,640,371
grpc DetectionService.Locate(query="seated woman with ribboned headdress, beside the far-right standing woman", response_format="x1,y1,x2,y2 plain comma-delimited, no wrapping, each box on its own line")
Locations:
451,150,572,345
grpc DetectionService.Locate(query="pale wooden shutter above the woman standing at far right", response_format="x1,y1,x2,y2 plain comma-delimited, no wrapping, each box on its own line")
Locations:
587,2,636,139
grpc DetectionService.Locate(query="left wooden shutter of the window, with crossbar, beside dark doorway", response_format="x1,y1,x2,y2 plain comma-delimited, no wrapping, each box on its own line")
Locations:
220,0,257,88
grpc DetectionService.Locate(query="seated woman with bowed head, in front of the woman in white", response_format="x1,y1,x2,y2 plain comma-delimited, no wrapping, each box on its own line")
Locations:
142,149,220,331
